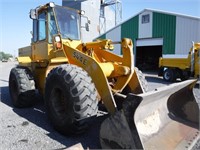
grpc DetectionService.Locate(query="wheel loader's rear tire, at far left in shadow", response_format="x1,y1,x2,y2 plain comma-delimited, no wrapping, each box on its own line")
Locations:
9,67,35,108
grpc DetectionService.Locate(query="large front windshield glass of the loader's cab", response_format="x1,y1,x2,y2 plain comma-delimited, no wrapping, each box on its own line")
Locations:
55,6,80,40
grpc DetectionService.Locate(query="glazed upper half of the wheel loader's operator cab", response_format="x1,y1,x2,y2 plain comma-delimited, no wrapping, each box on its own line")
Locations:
30,3,80,43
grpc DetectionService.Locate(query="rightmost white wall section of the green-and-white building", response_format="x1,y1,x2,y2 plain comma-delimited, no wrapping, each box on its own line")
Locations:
175,16,200,55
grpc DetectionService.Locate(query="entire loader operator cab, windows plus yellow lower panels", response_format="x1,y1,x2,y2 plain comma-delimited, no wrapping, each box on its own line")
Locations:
30,3,81,61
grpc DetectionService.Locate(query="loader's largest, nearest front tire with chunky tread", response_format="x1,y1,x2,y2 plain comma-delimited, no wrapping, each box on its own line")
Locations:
45,64,98,135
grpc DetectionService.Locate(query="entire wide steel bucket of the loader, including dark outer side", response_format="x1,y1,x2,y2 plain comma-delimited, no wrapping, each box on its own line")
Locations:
100,80,200,150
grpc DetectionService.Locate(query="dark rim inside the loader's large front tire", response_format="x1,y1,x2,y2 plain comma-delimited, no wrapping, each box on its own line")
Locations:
50,88,67,119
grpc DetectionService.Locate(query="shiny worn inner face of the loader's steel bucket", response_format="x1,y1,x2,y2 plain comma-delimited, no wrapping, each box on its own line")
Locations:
134,80,200,150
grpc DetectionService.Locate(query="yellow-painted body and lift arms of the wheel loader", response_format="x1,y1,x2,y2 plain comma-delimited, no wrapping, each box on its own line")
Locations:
18,2,144,113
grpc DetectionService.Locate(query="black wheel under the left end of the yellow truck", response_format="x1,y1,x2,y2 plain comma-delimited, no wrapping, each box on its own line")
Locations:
163,68,176,82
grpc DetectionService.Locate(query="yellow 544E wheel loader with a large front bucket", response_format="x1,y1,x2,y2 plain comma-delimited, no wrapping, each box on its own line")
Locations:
9,3,199,149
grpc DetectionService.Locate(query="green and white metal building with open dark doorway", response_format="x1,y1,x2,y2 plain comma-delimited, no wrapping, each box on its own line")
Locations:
98,9,200,70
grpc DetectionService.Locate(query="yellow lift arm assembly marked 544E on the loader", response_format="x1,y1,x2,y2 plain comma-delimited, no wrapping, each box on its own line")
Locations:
63,39,142,114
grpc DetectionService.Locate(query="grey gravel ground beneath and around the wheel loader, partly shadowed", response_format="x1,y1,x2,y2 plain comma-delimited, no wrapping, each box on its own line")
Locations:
0,62,200,150
